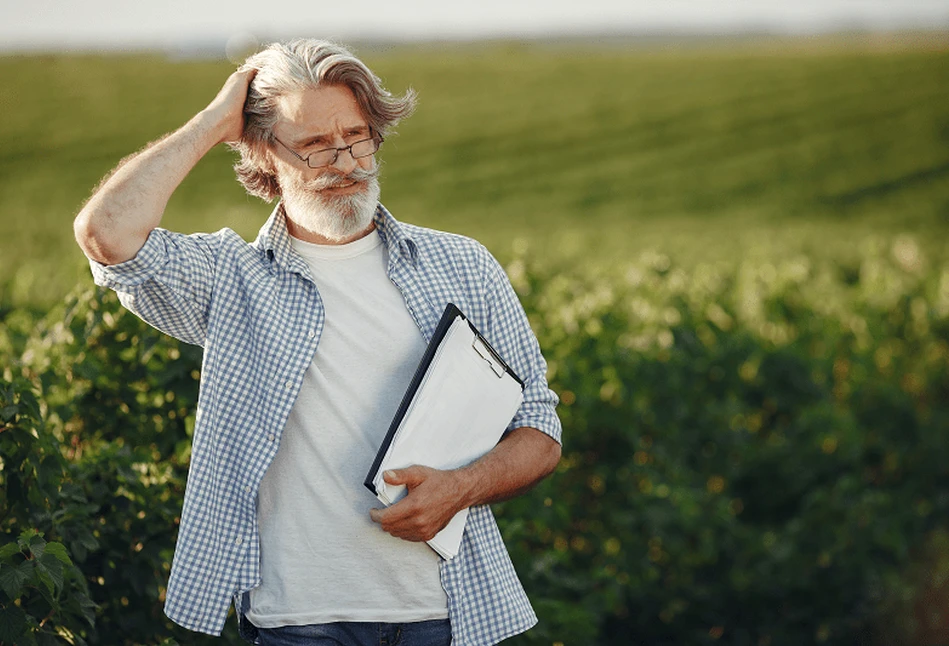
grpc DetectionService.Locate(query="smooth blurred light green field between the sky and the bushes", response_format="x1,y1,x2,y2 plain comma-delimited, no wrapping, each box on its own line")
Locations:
0,35,949,307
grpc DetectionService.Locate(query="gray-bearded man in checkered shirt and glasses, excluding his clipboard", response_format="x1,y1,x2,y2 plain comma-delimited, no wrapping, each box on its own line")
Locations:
75,40,561,646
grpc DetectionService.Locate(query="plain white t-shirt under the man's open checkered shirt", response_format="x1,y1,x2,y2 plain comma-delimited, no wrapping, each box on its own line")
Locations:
247,231,448,628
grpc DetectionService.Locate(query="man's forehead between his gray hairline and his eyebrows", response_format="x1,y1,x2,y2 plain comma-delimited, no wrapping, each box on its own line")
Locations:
274,85,368,142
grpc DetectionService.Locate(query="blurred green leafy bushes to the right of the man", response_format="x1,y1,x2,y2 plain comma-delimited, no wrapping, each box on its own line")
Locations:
499,239,949,646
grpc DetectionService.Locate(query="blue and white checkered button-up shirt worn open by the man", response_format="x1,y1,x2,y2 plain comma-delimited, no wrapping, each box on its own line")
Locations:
91,205,561,646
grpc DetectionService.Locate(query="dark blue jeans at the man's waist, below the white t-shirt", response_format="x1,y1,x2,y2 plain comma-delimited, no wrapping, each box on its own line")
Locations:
257,619,451,646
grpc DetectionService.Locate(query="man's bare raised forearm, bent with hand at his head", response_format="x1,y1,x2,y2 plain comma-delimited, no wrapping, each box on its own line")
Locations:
73,70,254,265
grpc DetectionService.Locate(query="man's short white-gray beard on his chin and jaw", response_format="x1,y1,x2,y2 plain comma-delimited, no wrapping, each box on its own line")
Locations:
282,177,380,242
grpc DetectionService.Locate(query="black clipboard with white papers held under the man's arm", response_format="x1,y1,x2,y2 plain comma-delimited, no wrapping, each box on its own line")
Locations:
364,303,524,560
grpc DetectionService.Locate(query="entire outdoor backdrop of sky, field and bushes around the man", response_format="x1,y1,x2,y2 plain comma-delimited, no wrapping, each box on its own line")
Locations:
0,0,949,646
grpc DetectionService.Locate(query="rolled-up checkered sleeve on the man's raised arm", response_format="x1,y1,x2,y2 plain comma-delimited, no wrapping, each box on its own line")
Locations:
89,228,221,345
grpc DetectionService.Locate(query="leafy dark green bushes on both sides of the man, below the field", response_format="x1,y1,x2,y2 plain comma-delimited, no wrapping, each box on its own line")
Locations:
0,236,949,646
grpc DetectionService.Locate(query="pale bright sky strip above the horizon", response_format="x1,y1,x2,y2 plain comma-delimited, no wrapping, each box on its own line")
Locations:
0,0,949,51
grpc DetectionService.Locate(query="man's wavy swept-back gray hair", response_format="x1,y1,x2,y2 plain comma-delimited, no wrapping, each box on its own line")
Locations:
230,38,415,202
